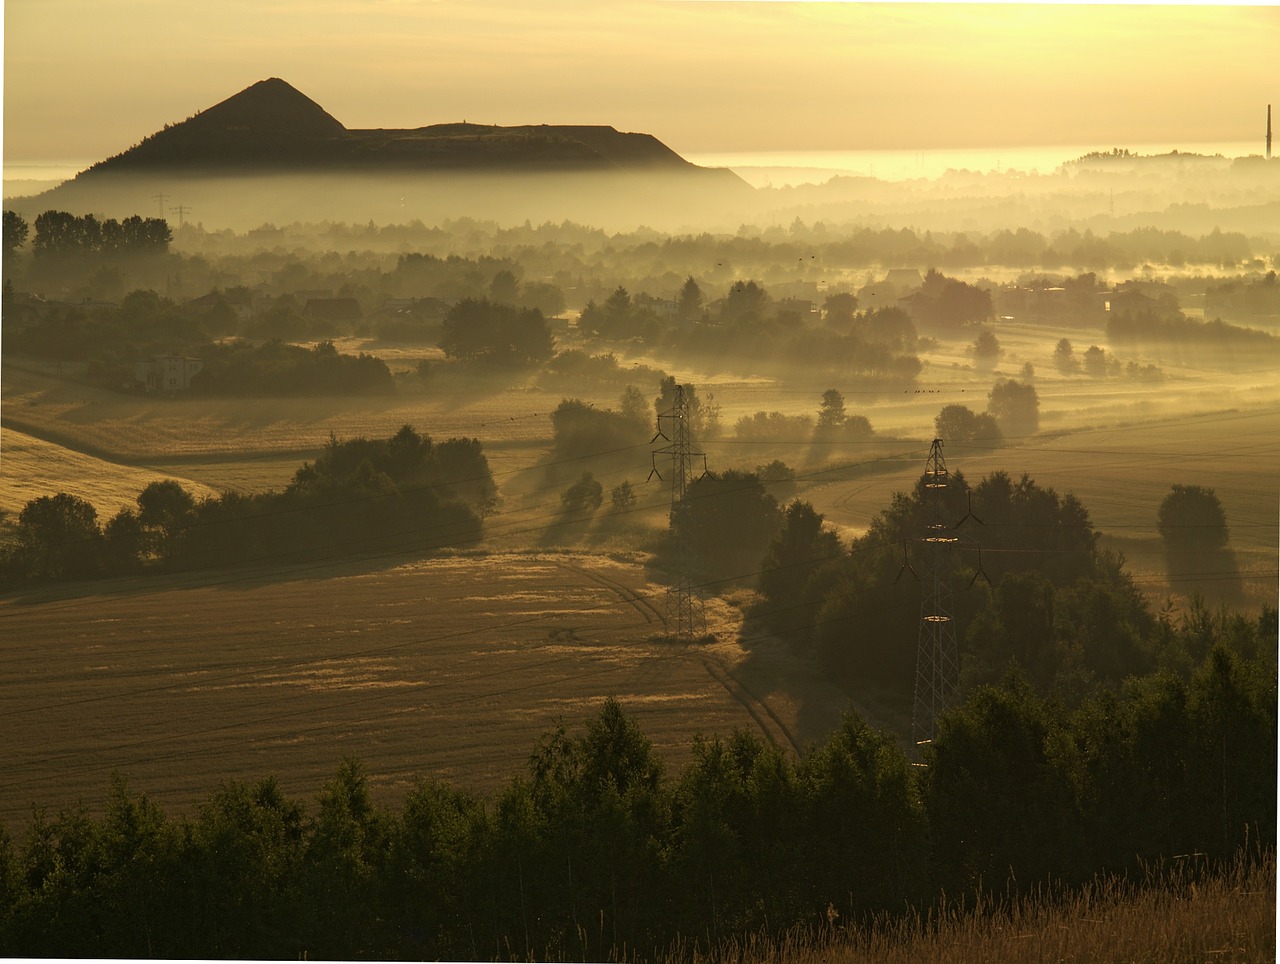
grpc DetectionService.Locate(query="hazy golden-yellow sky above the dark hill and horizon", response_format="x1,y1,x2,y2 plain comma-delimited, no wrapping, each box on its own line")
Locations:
4,0,1280,163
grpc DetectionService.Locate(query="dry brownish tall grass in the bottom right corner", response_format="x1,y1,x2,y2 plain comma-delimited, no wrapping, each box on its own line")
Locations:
666,851,1276,964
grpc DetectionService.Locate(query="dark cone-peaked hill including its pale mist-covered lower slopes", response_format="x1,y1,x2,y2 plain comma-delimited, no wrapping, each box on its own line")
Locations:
6,77,754,229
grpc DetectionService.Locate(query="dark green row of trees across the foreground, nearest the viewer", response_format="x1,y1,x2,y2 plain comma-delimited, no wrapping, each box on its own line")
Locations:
0,640,1276,960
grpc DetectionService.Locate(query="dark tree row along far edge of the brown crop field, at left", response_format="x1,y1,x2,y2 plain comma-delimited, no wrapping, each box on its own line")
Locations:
0,425,497,585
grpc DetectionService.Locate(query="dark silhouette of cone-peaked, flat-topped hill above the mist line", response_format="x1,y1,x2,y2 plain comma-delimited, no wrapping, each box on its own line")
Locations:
81,77,724,177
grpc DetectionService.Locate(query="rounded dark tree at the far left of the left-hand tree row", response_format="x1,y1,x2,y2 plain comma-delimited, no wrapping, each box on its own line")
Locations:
17,492,102,579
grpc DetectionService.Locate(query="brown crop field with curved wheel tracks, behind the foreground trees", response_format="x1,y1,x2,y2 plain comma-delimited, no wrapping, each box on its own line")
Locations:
0,552,847,830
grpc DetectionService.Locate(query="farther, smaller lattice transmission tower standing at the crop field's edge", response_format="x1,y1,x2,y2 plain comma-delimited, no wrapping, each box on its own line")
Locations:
649,385,707,640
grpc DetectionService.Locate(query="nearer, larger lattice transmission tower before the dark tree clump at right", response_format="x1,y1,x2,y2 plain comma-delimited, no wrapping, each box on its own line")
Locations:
911,439,964,746
